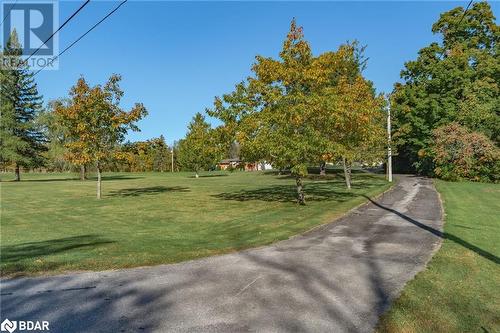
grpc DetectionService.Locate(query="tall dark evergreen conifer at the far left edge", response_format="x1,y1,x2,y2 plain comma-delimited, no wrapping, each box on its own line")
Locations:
0,30,45,181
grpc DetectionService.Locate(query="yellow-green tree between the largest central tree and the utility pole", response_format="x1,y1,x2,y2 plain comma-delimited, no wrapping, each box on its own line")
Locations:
313,41,385,189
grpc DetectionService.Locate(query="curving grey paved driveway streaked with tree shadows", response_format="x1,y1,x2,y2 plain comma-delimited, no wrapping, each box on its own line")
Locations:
0,176,442,332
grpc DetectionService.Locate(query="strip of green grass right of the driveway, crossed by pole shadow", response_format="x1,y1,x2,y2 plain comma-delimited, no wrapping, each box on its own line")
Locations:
378,181,500,333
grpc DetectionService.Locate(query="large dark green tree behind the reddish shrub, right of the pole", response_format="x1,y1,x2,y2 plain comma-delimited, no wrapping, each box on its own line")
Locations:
391,2,500,174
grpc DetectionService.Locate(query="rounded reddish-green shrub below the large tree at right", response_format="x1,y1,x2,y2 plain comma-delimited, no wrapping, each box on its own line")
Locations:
432,123,500,182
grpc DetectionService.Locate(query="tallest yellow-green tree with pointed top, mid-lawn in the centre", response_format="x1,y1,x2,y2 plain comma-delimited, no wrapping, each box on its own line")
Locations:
209,20,325,204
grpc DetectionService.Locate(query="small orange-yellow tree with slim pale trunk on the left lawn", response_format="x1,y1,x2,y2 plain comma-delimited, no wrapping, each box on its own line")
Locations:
54,74,147,199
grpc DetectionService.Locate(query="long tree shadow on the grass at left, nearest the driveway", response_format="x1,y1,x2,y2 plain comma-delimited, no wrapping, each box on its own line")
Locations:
0,235,114,265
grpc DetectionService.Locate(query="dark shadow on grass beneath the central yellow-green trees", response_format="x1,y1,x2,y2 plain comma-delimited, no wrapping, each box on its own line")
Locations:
214,180,377,202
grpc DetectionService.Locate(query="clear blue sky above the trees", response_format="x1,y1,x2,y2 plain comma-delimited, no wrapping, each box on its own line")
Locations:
33,1,500,143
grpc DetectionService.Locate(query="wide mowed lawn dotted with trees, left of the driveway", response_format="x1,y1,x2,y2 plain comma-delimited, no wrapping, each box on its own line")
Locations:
0,172,389,276
